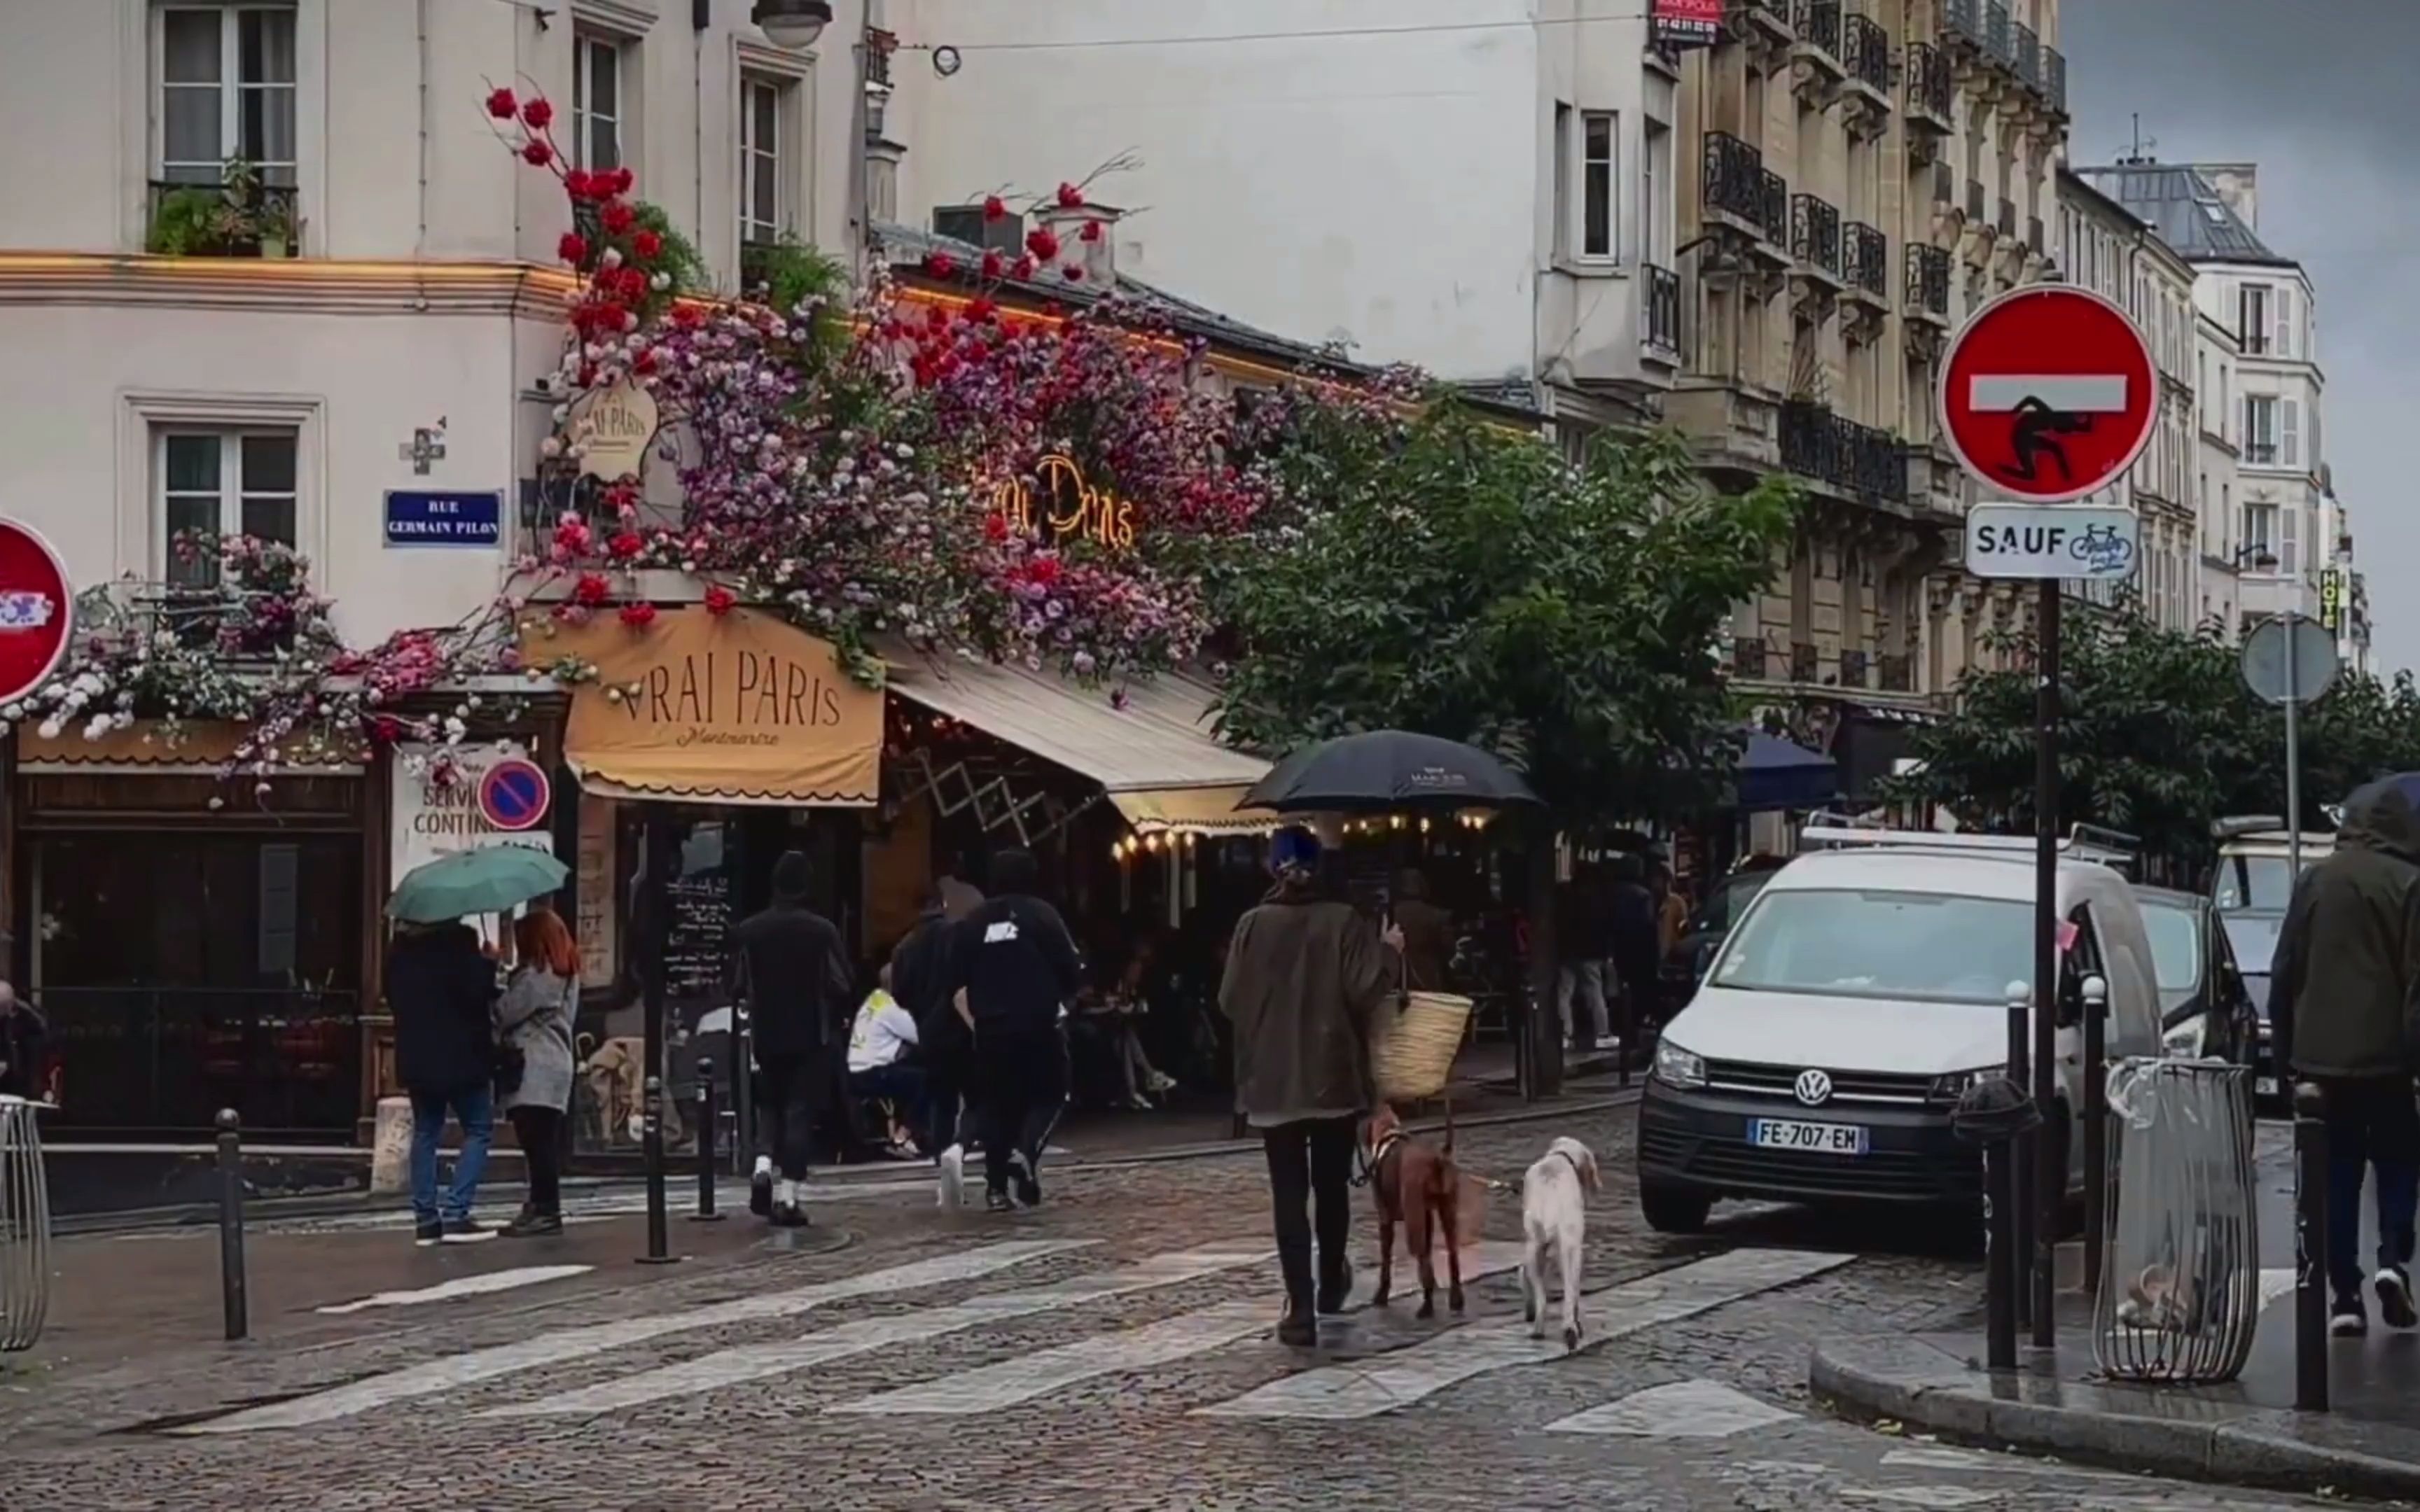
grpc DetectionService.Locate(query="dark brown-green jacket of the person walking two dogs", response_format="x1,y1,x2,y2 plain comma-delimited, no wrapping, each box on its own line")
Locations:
1217,878,1403,1123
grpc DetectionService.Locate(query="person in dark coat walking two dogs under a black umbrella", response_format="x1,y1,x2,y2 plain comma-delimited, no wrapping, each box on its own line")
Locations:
1217,830,1403,1345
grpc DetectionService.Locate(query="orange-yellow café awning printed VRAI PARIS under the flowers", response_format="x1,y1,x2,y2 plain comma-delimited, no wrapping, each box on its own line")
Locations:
522,607,883,808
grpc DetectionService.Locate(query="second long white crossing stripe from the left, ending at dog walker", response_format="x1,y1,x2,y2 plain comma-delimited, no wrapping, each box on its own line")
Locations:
482,1251,1273,1418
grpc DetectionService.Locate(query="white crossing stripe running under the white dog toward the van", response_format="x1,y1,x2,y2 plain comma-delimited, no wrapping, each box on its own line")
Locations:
1195,1251,1854,1420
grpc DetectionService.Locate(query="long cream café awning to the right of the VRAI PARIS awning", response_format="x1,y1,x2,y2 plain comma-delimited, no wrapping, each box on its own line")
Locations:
888,648,1273,834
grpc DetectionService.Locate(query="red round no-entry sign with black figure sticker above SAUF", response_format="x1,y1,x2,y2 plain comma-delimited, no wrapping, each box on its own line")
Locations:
1941,283,2159,503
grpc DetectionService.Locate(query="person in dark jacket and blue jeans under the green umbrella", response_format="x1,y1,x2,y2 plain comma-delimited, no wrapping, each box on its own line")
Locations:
387,919,496,1243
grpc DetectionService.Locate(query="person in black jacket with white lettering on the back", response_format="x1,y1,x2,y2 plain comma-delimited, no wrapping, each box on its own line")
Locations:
949,849,1084,1212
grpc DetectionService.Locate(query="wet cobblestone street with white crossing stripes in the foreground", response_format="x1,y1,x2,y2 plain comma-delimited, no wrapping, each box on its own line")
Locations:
0,1113,2342,1512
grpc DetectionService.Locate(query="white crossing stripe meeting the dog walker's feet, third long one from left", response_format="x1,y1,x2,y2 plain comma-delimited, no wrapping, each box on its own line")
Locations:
833,1243,1522,1418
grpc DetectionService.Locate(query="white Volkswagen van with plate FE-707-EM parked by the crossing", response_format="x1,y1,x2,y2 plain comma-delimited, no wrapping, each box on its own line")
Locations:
1639,827,2161,1234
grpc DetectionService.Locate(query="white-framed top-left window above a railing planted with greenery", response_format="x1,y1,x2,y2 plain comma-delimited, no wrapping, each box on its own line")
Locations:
153,5,295,186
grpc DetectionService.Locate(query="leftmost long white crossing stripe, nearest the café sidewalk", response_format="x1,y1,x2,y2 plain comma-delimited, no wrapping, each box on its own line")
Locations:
172,1238,1094,1434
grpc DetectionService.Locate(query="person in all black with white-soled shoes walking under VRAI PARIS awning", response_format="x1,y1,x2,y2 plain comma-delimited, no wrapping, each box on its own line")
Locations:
731,852,854,1229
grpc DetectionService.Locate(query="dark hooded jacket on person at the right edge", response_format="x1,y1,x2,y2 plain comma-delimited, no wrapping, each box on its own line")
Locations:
2270,779,2420,1077
